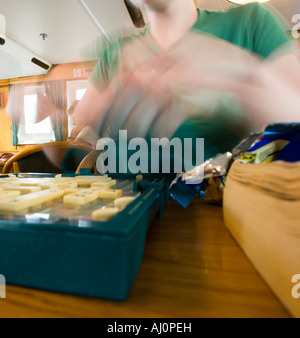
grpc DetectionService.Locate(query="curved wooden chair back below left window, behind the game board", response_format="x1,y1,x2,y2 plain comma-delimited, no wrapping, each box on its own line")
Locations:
3,141,94,174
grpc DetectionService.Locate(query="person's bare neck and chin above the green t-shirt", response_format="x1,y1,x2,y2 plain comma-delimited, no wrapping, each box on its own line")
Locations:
148,0,198,50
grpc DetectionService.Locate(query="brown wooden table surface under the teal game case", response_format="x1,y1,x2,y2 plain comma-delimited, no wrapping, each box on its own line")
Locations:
0,200,289,318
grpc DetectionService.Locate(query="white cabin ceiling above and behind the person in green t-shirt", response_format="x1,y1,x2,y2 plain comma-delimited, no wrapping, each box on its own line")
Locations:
0,0,300,67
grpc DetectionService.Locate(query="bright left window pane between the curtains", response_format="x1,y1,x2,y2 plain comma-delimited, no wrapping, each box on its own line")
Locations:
18,86,55,145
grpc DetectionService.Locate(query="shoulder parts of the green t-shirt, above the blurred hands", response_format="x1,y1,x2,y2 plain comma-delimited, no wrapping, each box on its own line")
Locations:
90,3,289,88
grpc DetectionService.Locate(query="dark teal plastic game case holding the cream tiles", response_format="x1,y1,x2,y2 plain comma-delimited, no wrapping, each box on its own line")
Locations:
0,175,169,301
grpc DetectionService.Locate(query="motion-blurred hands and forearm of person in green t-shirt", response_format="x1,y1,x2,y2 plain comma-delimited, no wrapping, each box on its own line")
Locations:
74,33,300,137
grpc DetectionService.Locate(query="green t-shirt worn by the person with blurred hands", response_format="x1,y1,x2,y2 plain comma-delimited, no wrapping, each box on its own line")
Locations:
90,3,289,159
